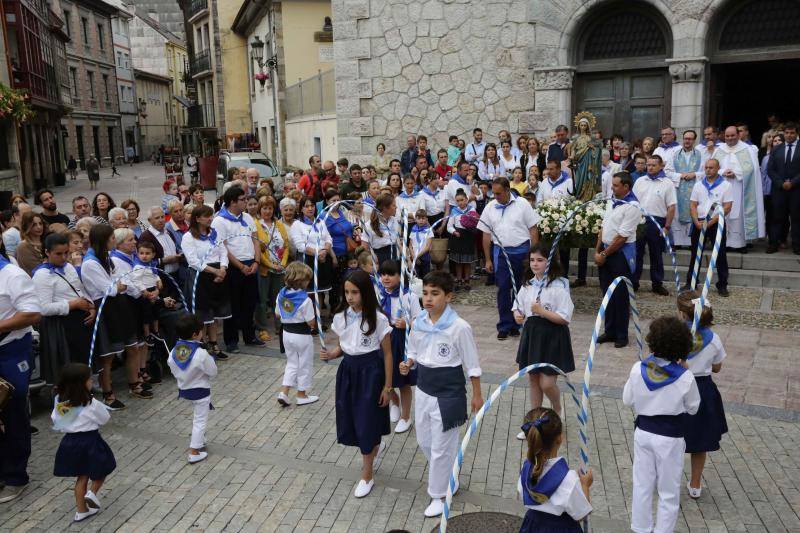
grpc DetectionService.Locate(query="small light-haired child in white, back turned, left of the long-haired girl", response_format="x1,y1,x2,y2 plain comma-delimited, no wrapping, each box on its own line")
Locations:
275,261,319,407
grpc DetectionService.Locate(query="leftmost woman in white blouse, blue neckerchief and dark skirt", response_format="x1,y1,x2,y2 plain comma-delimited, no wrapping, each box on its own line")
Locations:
33,233,95,384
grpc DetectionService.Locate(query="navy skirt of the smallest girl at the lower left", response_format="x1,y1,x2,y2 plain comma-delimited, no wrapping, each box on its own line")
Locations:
53,430,117,481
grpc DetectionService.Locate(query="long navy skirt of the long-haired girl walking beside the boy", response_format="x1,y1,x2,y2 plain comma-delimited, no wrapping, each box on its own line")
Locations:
336,350,391,455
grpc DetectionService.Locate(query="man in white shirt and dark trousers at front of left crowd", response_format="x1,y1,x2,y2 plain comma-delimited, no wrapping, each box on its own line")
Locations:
211,186,264,353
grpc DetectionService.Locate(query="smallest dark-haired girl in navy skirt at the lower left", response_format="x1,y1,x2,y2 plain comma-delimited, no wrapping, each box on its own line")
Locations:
50,362,117,522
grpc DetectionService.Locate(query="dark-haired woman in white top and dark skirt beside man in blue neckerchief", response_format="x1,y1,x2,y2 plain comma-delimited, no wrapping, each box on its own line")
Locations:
181,205,231,360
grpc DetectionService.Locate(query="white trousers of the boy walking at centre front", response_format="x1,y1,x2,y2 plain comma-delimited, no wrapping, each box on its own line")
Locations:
414,387,459,498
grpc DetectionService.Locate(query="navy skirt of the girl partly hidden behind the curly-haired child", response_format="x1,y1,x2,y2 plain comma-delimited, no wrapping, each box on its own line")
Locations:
684,376,728,453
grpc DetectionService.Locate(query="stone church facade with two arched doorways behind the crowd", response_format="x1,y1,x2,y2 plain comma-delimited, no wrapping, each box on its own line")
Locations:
333,0,800,160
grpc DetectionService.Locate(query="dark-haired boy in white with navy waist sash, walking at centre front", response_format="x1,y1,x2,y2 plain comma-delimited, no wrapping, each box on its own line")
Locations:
399,271,483,518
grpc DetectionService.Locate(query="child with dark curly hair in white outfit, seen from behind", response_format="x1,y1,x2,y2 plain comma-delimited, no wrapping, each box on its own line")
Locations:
622,316,700,533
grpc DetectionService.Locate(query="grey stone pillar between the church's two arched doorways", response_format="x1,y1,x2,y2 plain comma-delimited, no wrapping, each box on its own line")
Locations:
667,57,708,136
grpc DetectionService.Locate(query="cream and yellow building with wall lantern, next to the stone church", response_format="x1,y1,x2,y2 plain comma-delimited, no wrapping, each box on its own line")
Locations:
233,0,338,168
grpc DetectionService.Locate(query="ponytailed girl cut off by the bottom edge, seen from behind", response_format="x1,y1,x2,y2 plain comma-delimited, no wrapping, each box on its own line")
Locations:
517,407,594,533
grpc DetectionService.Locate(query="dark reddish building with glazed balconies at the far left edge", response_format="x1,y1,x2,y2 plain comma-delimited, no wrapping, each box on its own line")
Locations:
0,0,71,193
